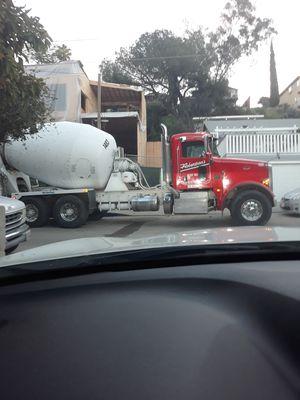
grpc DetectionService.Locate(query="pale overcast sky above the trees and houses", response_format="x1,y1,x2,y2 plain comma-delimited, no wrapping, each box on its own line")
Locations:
14,0,300,106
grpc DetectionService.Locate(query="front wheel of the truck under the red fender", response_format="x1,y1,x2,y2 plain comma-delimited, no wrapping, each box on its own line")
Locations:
230,190,272,226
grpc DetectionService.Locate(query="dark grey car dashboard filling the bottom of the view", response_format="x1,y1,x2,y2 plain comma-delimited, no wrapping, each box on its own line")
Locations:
0,261,300,400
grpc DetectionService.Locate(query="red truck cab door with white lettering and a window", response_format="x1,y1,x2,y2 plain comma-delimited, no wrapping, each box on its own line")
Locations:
178,139,211,190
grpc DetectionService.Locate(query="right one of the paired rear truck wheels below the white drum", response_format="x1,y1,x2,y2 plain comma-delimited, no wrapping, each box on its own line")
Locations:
53,195,88,228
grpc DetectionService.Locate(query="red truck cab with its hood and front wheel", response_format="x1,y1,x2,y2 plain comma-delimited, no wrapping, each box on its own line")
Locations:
170,132,274,225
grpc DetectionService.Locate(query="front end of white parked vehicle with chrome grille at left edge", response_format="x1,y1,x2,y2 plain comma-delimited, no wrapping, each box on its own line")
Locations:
0,196,30,254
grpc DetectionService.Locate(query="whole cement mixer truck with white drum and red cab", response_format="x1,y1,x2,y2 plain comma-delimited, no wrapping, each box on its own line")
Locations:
0,122,274,228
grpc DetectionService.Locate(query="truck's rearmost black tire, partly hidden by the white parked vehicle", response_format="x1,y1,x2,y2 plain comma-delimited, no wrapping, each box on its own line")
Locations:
21,197,50,228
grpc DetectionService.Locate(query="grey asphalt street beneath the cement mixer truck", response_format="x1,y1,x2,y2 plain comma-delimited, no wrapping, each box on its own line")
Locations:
16,210,300,251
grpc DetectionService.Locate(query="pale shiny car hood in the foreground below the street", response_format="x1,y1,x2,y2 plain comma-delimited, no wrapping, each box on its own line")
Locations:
0,227,300,267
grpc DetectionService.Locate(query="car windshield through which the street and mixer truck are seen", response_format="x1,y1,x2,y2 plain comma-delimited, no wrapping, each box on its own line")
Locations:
0,0,300,265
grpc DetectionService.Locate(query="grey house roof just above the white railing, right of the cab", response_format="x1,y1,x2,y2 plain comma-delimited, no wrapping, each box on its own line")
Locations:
204,118,300,132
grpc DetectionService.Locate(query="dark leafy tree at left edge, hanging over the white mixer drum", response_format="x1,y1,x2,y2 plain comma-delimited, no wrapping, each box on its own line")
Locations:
0,0,51,142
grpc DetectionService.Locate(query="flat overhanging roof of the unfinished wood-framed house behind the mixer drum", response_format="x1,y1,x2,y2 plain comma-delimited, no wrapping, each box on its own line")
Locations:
90,81,143,105
